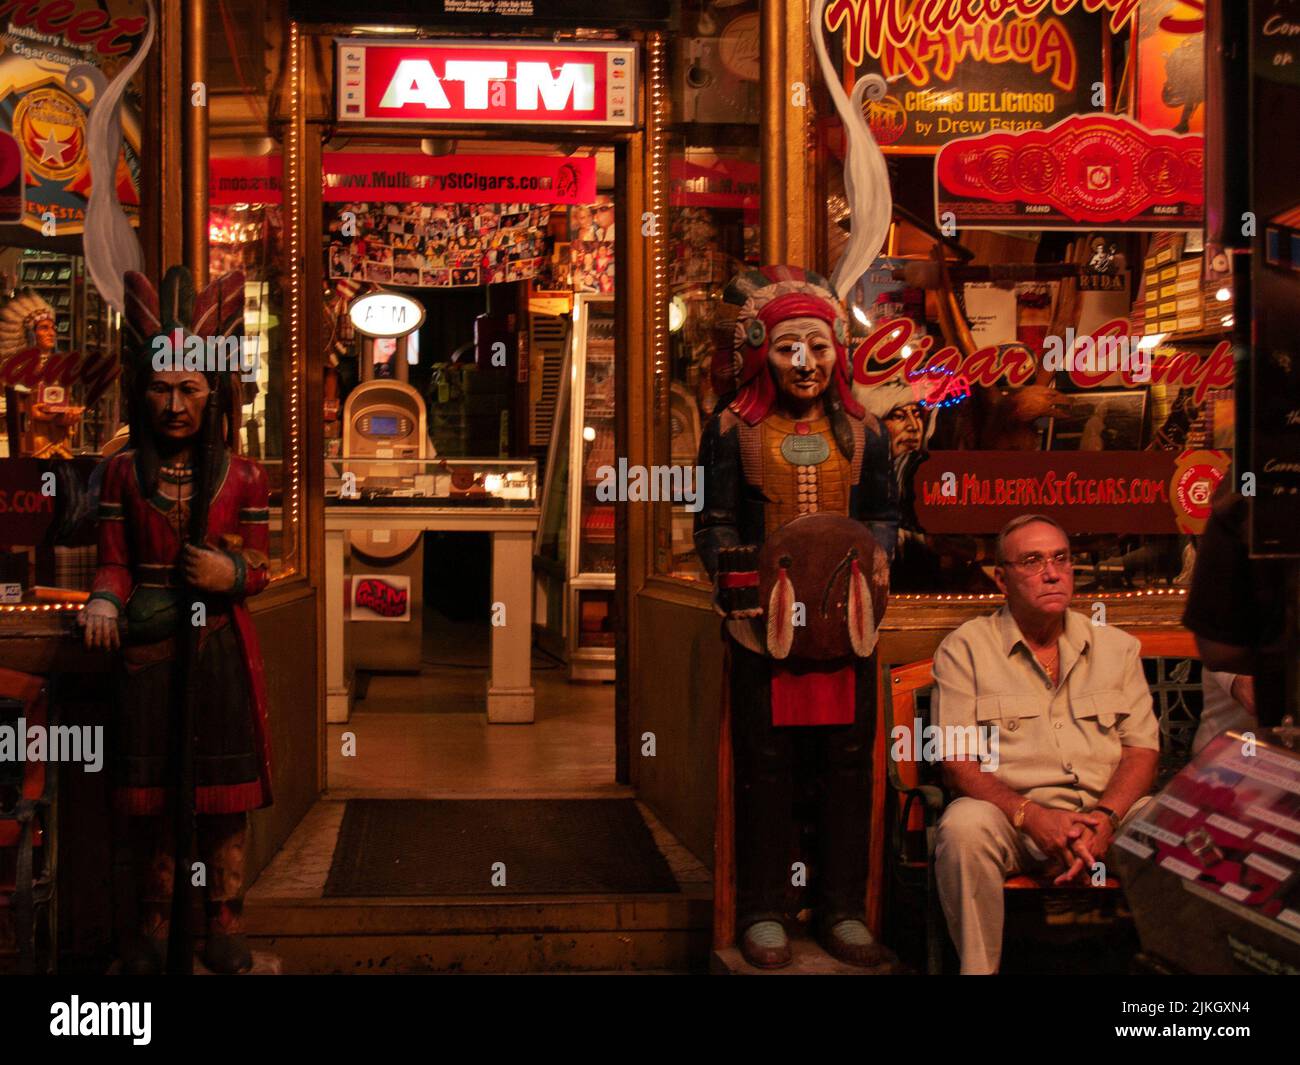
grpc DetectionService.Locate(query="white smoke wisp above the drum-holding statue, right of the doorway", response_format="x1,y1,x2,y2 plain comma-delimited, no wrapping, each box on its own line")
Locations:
809,0,893,300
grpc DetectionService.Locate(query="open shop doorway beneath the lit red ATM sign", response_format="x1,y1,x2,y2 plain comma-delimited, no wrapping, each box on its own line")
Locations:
321,135,623,797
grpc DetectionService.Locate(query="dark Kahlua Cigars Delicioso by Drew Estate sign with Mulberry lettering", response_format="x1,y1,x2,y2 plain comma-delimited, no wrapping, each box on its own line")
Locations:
826,0,1138,153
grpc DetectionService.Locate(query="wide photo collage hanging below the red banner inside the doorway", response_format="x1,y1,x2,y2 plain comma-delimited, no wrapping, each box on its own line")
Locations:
325,203,551,289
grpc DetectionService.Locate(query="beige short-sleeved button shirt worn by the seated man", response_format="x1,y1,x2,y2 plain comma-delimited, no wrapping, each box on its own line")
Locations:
933,606,1160,810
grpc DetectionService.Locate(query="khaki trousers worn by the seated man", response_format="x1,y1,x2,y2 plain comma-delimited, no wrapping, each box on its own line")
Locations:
935,797,1151,975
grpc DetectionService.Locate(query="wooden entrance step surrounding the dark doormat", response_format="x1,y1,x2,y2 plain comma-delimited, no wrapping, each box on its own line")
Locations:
244,792,712,974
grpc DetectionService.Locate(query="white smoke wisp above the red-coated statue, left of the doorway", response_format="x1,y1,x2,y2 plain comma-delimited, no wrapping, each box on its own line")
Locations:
66,0,157,313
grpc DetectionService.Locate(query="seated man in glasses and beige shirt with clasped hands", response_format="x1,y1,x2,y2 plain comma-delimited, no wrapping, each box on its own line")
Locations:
935,514,1160,974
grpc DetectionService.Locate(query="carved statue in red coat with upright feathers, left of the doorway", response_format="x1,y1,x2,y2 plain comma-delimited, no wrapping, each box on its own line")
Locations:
82,267,272,973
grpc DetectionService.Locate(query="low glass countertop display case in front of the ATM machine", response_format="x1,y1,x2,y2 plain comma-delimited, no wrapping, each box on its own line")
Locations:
325,458,537,510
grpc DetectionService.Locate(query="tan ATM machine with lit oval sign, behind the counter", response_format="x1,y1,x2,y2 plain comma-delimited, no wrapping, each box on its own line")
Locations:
342,293,434,672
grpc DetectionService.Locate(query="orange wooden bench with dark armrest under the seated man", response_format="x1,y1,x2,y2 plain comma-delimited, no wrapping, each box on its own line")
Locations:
871,629,1199,974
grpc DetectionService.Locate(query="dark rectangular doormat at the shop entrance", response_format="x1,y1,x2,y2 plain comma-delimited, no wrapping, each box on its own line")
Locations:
325,798,677,899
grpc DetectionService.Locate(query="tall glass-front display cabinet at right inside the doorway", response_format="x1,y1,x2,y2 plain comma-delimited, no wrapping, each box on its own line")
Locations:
534,294,615,680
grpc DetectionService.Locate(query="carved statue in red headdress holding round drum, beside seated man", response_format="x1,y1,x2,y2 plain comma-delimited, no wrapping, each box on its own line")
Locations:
696,267,898,967
